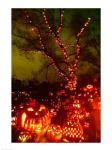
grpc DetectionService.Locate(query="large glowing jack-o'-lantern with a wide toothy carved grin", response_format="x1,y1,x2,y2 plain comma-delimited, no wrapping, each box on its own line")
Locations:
21,105,50,133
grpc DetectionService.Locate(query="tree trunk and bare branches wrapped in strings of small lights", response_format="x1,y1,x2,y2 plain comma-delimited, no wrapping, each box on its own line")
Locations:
22,9,91,91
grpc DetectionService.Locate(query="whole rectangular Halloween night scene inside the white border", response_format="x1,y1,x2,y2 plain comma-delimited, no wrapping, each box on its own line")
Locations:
11,9,101,143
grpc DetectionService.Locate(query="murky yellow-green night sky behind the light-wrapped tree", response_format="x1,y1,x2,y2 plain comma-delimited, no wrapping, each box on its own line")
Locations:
12,9,100,82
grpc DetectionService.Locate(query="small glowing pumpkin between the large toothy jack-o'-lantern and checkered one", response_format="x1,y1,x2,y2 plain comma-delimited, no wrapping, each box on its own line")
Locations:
47,124,62,142
